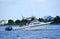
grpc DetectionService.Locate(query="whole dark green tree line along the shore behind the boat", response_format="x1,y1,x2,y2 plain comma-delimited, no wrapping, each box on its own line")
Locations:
7,16,60,25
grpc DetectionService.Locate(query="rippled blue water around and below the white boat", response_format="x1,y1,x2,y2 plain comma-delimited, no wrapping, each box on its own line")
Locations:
0,25,60,39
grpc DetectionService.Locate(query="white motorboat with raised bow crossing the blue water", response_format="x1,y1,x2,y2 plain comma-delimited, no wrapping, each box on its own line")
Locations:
20,20,50,30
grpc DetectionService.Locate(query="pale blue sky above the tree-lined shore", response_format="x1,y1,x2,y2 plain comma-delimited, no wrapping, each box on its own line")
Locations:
0,0,60,20
